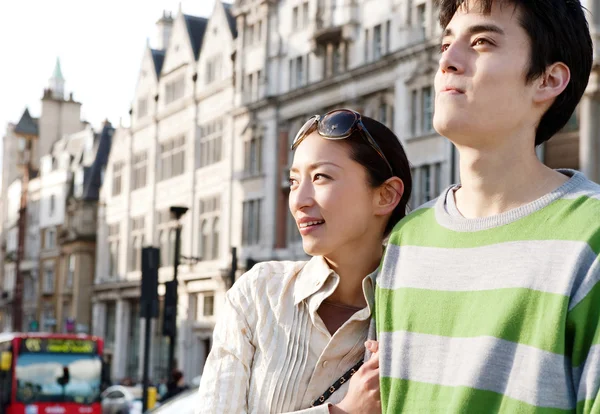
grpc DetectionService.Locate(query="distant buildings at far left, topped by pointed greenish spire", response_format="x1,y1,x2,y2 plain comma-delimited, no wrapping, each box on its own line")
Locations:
0,60,113,332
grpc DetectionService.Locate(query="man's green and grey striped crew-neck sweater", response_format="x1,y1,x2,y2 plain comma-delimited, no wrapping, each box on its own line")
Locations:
374,170,600,413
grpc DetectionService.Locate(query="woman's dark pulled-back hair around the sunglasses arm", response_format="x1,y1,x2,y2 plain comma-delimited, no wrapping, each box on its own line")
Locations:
341,116,412,236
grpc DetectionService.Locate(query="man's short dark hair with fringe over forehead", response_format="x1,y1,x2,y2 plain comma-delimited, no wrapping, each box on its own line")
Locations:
439,0,593,145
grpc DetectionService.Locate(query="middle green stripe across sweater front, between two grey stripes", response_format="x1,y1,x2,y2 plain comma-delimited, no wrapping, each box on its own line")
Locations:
376,287,569,355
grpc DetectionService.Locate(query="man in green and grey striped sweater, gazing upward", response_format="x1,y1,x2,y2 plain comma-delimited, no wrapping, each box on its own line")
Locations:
375,0,600,413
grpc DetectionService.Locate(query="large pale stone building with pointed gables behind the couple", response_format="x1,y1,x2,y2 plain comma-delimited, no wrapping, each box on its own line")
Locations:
93,0,600,380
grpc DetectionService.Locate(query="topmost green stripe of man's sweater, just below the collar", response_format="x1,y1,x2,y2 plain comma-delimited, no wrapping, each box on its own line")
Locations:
390,197,600,254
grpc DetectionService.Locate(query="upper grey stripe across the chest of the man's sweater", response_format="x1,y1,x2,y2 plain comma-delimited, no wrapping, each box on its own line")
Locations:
377,240,596,296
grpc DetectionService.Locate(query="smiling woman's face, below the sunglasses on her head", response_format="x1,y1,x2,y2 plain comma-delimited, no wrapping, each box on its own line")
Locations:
289,132,381,257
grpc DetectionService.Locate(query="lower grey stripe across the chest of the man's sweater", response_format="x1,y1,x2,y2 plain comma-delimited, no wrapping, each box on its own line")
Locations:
380,331,575,410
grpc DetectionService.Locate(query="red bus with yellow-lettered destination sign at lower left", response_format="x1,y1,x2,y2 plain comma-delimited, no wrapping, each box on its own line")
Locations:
0,333,103,414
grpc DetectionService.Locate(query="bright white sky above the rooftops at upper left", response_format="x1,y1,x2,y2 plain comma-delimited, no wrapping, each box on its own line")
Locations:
0,0,215,133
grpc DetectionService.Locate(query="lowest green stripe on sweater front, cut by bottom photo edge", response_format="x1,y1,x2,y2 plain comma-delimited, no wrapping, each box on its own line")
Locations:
380,378,572,414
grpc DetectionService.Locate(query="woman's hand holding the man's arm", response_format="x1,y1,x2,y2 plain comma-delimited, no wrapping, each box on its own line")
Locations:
329,341,381,414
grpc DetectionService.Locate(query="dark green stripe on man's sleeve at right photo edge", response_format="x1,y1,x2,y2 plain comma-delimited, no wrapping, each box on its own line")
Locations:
567,283,600,367
